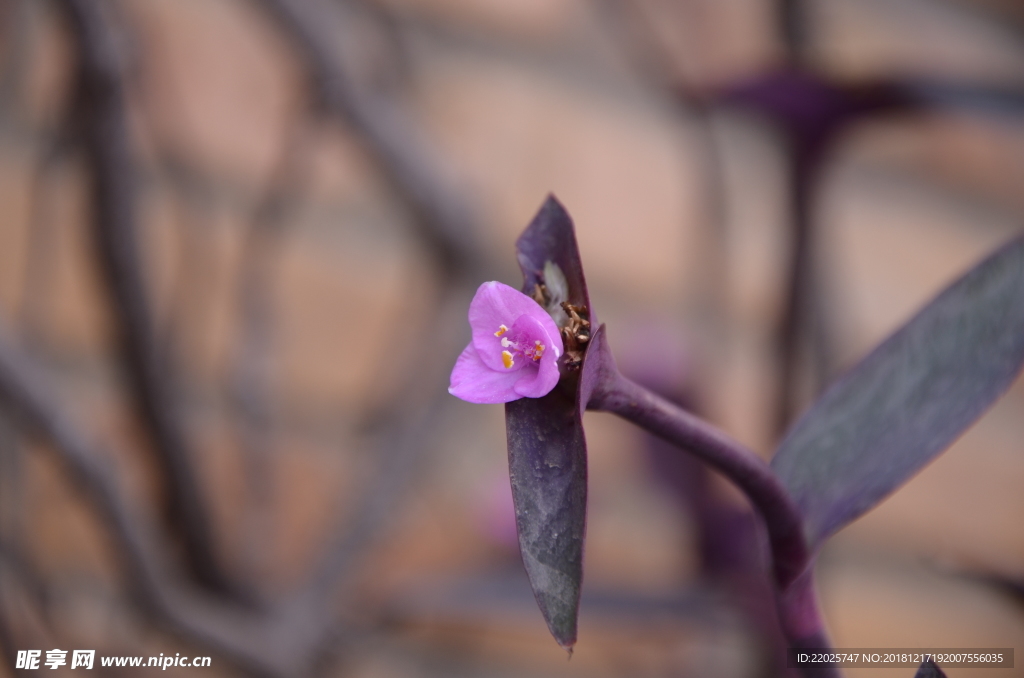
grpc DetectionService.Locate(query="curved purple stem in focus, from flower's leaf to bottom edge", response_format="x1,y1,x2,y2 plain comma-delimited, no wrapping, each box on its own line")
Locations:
587,348,840,678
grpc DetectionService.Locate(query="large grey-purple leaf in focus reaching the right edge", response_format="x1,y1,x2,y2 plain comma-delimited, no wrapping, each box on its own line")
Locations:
771,238,1024,545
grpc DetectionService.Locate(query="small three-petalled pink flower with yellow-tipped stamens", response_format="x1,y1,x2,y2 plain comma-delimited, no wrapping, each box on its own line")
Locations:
449,282,562,402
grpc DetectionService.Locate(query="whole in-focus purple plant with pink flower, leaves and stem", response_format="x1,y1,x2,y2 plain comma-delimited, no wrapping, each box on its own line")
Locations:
449,193,1024,677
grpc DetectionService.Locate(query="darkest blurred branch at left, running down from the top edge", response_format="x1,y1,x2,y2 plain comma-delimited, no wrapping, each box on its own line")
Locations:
58,0,231,592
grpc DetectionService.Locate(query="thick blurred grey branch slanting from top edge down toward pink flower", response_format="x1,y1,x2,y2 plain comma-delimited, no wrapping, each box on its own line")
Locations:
247,0,485,280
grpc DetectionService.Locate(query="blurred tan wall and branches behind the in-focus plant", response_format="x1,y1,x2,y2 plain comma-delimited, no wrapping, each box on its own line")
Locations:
0,0,1024,678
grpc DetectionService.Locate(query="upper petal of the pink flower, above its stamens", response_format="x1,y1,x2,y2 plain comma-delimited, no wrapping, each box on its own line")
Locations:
469,281,561,372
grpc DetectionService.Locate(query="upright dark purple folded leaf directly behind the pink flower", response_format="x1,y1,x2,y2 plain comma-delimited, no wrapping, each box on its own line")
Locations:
505,197,593,648
